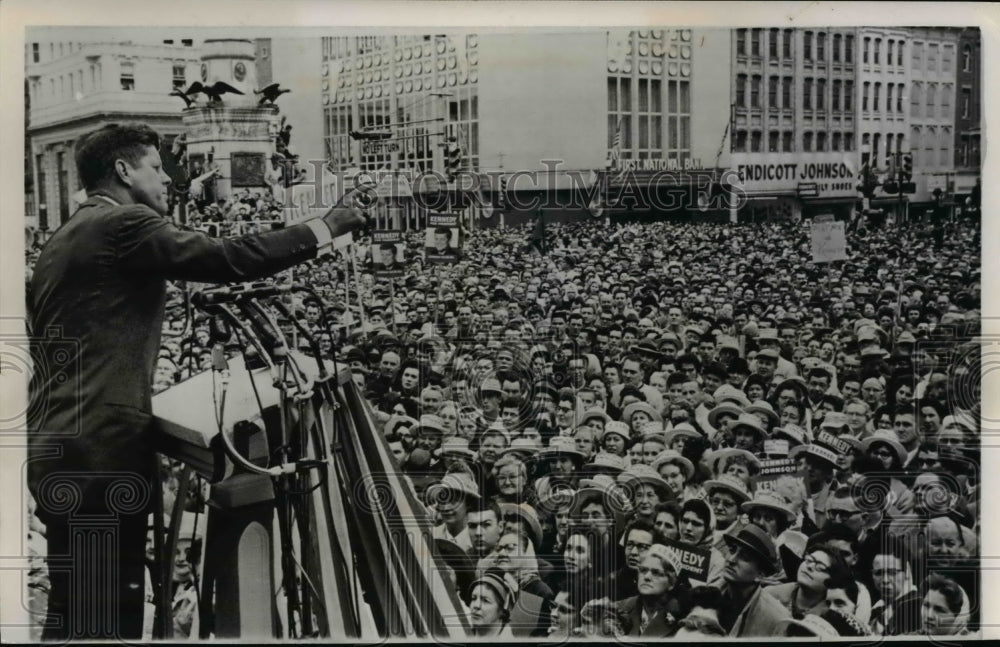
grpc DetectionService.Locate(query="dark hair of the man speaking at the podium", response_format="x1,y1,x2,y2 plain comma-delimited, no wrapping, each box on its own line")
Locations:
74,124,160,191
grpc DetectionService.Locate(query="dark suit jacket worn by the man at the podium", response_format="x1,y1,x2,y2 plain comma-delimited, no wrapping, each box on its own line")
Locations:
28,196,317,521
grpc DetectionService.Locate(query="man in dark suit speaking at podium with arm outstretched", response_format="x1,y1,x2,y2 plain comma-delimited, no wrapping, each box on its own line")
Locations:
28,124,364,640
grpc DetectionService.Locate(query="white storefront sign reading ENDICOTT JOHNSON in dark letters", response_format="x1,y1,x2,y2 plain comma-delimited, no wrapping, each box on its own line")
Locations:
729,152,858,198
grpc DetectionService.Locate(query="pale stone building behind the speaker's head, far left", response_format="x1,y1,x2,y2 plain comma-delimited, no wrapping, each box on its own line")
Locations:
25,30,200,232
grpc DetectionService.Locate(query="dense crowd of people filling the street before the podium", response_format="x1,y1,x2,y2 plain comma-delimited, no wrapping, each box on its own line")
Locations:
27,205,981,639
